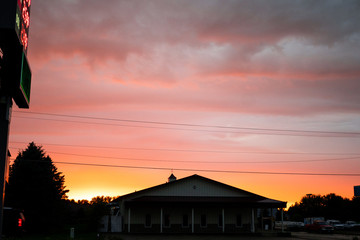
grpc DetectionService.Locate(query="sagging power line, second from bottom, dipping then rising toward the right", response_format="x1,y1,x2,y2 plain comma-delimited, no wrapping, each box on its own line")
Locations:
7,146,360,164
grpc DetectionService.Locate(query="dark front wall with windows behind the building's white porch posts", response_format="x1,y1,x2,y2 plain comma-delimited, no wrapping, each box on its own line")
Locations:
123,206,251,233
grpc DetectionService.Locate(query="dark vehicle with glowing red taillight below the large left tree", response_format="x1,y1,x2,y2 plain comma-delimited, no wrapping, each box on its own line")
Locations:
3,207,25,236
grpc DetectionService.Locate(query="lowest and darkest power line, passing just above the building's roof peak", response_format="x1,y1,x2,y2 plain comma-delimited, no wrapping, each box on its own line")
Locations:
7,160,360,177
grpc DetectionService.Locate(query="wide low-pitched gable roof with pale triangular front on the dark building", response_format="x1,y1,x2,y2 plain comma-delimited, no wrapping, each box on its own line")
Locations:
113,174,286,206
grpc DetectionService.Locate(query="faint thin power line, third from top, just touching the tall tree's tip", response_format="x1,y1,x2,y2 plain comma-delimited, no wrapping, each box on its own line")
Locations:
10,141,360,156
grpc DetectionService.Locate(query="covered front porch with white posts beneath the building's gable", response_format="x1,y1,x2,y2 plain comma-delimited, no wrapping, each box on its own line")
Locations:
123,196,286,233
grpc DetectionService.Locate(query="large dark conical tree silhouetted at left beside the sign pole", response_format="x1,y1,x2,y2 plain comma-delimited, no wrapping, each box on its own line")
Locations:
5,142,68,231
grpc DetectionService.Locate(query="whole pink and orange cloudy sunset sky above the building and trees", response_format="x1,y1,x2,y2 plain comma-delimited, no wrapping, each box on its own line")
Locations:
9,0,360,205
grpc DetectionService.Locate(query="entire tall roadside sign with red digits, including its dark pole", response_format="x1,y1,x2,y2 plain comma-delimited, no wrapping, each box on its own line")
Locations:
0,0,31,236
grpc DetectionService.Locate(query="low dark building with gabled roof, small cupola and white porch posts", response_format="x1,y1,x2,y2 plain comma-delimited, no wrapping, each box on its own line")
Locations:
106,174,286,233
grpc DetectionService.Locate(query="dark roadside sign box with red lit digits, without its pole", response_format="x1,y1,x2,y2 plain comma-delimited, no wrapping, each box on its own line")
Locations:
0,0,31,108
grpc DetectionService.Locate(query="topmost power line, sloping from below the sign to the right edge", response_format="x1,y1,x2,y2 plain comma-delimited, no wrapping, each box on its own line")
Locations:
13,110,360,137
